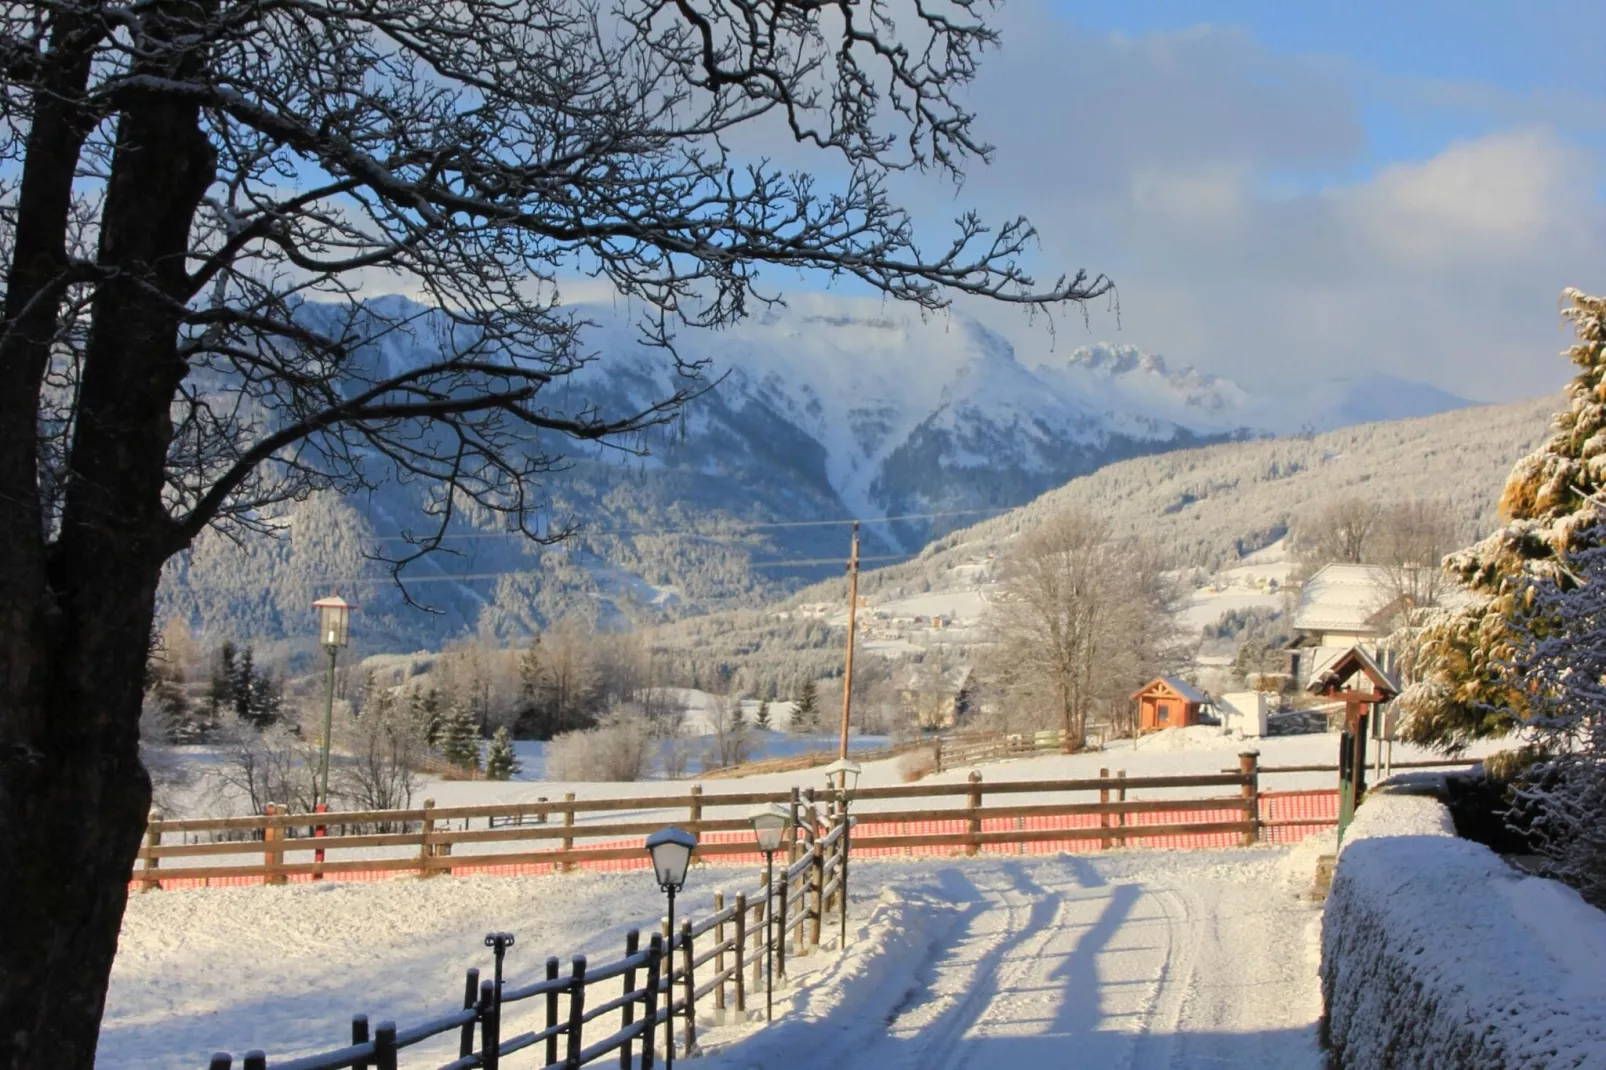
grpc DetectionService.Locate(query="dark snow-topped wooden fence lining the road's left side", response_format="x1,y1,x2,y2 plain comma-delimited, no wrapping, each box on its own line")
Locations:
207,811,845,1070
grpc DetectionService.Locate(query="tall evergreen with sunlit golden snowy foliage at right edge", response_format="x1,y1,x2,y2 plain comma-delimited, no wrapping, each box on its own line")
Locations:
1392,289,1606,750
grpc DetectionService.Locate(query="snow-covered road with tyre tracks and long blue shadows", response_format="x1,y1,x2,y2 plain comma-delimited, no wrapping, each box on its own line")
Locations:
703,852,1322,1070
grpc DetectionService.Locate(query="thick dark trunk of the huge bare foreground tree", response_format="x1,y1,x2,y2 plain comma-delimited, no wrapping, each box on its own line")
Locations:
0,8,215,1070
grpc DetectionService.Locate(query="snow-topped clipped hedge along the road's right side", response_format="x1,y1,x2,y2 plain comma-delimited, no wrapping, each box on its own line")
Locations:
1322,786,1606,1070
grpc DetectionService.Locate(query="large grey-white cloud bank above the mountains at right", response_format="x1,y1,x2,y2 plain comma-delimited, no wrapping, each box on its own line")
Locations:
922,5,1606,400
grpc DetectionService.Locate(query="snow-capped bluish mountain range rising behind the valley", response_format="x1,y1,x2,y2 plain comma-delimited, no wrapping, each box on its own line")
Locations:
164,294,1461,647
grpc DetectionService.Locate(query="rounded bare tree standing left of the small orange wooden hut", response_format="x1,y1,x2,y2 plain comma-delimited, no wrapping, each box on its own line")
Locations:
988,511,1172,749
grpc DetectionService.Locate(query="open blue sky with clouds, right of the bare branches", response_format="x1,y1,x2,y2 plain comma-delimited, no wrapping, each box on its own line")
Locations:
899,0,1606,400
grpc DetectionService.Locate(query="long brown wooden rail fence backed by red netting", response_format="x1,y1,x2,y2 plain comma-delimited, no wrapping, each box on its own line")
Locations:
132,752,1338,890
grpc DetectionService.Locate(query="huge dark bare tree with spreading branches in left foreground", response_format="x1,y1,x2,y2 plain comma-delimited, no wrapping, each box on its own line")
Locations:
0,0,1108,1047
